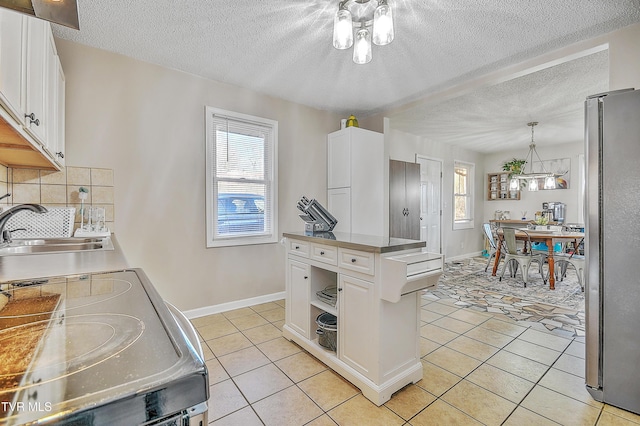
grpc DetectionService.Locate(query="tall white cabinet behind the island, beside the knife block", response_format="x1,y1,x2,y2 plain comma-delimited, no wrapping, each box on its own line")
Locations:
327,127,387,235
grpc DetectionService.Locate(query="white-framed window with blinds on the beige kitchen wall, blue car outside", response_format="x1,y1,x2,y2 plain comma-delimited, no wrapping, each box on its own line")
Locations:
206,107,278,247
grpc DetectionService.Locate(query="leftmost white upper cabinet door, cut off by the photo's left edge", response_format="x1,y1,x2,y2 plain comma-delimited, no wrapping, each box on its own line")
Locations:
0,9,26,124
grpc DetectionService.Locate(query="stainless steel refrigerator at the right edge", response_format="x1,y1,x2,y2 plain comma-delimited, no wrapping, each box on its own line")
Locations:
585,89,640,413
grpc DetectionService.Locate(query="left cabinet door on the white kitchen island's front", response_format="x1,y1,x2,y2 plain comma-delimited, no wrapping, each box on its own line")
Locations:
286,260,311,339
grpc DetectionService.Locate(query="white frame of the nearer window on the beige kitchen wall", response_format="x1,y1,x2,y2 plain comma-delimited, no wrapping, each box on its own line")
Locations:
205,106,278,248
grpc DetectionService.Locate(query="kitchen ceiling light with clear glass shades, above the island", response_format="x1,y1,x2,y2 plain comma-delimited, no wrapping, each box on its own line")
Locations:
333,0,394,65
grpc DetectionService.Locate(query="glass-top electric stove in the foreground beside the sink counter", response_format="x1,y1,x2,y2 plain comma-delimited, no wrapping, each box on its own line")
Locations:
0,269,208,424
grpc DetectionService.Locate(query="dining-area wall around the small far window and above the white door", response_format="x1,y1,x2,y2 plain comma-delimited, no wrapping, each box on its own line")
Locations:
385,125,484,259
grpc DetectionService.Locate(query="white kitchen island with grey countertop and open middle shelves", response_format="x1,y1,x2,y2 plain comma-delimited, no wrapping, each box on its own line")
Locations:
283,232,443,405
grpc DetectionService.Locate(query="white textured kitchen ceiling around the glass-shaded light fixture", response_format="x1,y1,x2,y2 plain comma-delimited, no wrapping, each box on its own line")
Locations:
54,0,640,151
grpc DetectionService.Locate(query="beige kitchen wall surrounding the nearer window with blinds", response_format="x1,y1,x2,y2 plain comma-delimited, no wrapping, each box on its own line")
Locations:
56,39,340,310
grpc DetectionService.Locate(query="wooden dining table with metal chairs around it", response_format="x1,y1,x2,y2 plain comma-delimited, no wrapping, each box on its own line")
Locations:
491,228,584,290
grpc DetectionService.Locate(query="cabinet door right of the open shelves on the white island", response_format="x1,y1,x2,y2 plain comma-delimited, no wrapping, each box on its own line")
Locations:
338,274,375,376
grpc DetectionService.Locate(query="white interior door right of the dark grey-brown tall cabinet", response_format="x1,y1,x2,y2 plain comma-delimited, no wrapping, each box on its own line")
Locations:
416,155,442,253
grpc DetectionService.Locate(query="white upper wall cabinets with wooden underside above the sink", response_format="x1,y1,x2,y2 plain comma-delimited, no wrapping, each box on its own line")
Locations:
0,9,65,170
